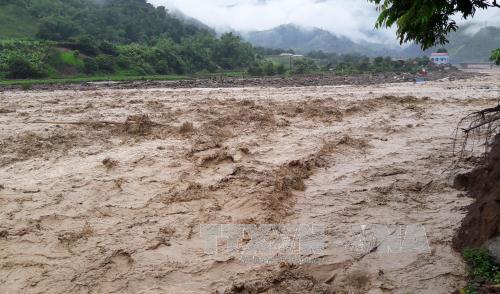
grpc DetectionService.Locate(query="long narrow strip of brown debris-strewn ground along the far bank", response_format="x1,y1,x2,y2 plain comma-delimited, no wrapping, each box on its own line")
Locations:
0,69,479,91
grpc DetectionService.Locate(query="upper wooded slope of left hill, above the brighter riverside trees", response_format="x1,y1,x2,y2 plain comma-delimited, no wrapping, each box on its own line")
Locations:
0,0,207,43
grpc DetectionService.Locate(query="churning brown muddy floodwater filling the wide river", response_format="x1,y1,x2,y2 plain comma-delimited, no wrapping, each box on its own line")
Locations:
0,72,500,293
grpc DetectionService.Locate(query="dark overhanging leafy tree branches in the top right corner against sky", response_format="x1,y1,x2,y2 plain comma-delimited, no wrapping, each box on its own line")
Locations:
368,0,500,49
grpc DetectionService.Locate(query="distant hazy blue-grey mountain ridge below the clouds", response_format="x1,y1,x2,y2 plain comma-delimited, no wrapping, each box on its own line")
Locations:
242,24,500,62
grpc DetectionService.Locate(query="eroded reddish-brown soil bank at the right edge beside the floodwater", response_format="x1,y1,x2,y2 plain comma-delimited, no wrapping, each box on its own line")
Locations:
453,135,500,251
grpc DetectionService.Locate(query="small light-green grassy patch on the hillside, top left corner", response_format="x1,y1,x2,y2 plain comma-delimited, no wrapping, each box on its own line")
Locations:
0,4,37,39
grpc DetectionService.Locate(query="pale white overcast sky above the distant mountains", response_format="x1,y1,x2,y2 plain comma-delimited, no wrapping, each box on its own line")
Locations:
148,0,500,44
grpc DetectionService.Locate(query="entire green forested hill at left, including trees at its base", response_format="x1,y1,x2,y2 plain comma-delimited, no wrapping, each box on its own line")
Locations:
0,0,262,79
